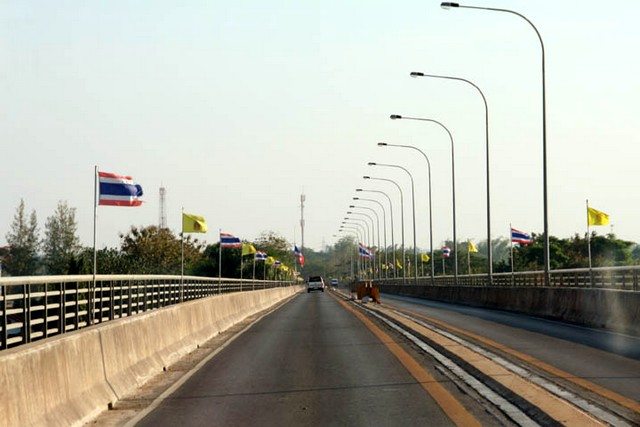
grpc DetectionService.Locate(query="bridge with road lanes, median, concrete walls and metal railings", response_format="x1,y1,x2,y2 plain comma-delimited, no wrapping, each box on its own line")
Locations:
0,268,640,426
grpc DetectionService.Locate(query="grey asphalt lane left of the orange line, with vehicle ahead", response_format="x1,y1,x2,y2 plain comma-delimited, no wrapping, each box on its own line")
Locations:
138,293,460,426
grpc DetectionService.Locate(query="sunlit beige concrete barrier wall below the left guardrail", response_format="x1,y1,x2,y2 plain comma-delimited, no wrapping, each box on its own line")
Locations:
0,286,302,426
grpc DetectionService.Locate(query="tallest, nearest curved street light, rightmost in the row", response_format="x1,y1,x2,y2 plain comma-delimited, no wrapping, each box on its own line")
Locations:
440,2,550,286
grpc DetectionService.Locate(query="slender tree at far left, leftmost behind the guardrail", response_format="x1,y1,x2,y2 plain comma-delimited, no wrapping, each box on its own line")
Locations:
5,199,39,276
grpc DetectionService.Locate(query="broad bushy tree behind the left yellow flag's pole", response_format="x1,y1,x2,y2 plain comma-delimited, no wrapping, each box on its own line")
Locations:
120,225,203,274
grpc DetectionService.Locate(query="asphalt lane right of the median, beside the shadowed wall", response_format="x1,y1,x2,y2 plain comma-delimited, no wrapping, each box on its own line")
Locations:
382,294,640,401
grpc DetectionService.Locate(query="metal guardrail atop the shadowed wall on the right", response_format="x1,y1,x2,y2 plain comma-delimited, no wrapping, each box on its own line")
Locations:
374,266,640,292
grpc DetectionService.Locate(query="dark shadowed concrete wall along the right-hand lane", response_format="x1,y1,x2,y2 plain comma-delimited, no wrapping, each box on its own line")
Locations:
380,285,640,336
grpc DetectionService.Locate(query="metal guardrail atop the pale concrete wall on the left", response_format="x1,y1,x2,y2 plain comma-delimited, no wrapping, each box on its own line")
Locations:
0,275,293,350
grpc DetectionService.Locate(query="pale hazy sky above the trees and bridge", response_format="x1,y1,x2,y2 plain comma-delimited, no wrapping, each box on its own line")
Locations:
0,0,640,249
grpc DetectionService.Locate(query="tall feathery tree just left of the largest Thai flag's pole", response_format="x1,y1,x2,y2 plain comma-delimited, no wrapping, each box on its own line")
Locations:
42,201,80,274
